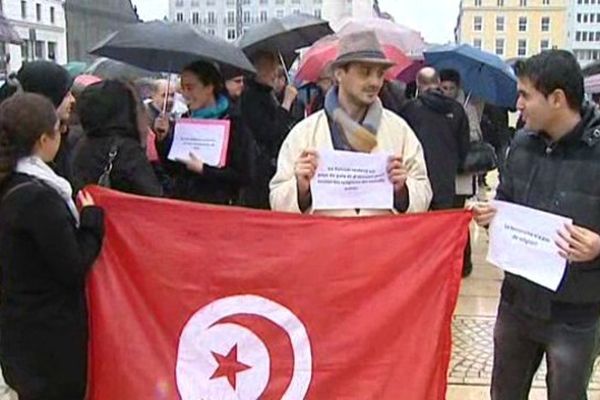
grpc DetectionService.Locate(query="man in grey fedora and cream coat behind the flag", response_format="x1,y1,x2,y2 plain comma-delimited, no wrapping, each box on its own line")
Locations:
270,31,432,216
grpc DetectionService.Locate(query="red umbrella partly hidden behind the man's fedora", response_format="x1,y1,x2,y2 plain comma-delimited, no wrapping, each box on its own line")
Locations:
296,35,413,82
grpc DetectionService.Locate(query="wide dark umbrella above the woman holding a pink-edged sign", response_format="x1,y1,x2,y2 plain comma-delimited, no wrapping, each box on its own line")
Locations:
90,21,255,73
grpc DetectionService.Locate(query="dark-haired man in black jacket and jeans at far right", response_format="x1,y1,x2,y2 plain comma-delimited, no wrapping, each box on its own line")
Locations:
475,50,600,400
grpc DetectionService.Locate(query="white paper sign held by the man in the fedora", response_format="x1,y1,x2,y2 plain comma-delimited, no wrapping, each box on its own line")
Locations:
310,150,394,210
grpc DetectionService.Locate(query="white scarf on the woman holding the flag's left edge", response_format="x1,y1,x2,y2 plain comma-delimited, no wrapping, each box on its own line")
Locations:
15,156,79,226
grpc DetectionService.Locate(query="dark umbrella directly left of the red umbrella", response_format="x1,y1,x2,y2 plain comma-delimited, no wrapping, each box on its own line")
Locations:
236,14,333,66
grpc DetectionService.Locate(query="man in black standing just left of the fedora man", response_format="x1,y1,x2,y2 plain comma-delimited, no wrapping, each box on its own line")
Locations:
241,51,298,209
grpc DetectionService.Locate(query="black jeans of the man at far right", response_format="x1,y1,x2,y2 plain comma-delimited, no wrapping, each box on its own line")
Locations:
491,301,599,400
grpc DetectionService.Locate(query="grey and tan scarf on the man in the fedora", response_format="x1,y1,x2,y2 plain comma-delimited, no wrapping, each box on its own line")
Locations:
325,87,383,153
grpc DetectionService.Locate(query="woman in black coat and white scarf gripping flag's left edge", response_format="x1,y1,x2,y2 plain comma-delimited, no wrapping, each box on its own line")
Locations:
0,93,104,400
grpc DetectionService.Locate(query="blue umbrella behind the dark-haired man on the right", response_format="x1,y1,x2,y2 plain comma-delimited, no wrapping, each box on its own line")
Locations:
424,44,517,108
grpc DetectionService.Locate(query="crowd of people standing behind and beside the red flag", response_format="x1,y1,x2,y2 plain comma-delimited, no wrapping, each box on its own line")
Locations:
0,28,600,400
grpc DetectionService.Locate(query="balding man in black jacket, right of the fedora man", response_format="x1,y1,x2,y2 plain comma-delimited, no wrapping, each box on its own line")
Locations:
400,67,469,210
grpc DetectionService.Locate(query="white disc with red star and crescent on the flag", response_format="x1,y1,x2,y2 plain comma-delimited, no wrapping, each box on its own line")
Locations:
176,295,312,400
